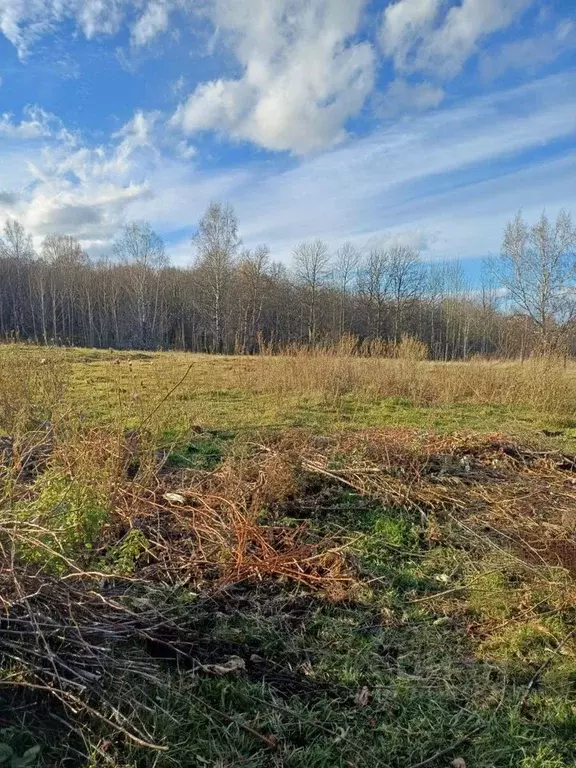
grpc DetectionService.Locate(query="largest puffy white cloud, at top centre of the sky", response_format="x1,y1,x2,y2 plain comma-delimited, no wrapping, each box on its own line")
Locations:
173,0,375,154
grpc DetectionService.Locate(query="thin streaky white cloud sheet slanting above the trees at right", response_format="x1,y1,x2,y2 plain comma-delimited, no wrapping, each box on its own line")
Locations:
192,70,576,258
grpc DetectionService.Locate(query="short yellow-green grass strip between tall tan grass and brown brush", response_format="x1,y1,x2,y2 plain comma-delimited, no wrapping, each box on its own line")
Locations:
50,350,576,448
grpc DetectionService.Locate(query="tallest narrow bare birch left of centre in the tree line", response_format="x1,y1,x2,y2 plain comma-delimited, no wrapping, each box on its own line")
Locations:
192,202,241,352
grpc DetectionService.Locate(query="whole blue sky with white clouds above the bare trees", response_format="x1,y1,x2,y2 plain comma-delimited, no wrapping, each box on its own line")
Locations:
0,0,576,282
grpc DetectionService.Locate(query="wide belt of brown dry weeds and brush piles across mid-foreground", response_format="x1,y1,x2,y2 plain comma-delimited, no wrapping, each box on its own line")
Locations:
0,429,576,765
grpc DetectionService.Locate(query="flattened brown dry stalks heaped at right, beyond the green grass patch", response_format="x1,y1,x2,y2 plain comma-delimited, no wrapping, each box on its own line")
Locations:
286,429,576,575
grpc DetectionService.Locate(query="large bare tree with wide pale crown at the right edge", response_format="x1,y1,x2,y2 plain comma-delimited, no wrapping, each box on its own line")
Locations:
492,211,576,347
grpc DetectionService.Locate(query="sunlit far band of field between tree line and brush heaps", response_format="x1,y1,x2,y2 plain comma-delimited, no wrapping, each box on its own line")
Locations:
0,343,576,433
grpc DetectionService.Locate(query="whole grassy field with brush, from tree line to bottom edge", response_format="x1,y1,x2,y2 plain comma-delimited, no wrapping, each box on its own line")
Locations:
0,345,576,768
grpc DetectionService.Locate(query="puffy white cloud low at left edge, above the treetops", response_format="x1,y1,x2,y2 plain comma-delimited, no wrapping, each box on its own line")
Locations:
0,107,159,243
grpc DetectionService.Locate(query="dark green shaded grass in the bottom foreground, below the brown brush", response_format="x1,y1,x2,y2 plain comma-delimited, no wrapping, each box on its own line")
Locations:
68,494,576,768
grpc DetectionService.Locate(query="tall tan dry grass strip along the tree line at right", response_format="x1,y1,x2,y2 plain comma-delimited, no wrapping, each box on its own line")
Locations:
238,352,576,417
